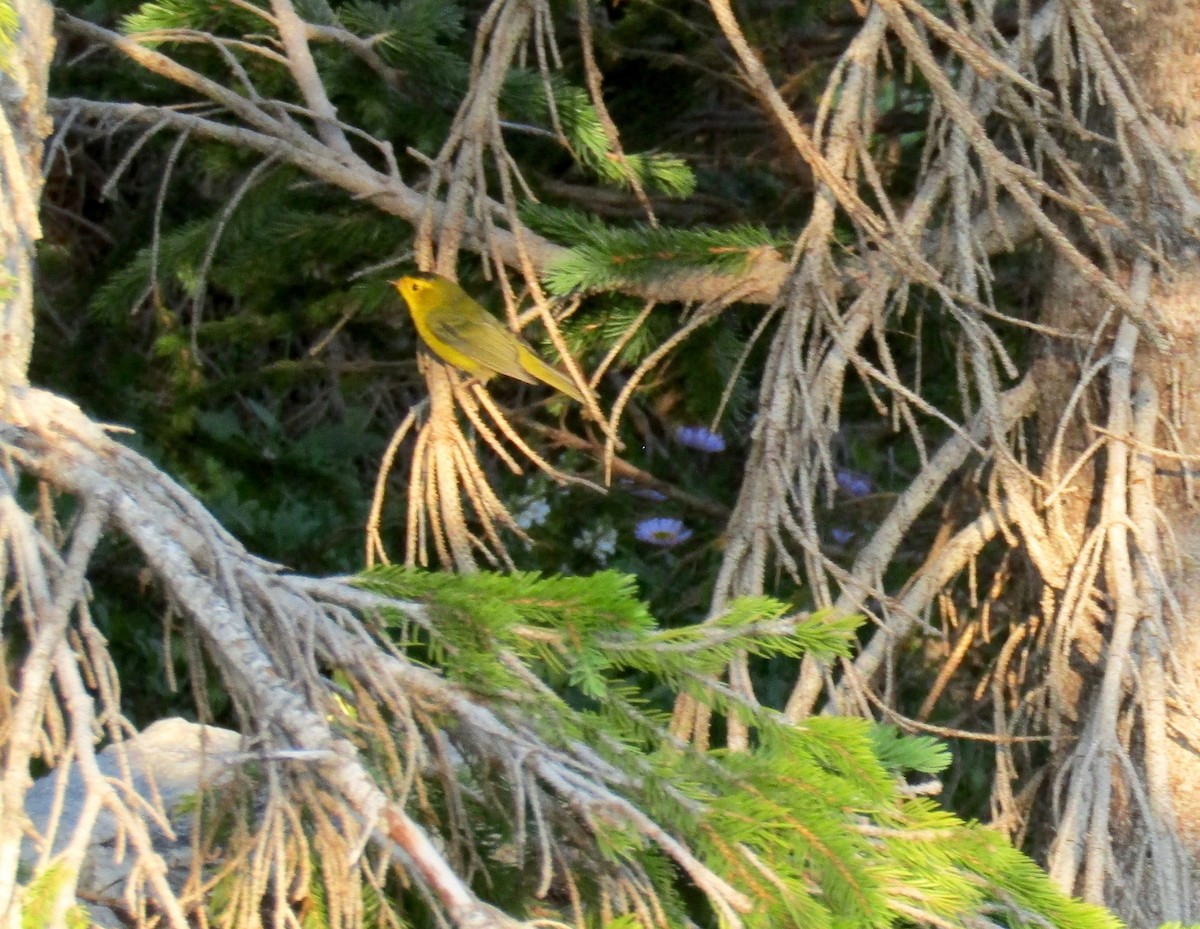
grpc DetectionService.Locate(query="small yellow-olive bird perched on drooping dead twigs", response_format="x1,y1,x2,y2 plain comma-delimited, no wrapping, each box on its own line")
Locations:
390,272,583,403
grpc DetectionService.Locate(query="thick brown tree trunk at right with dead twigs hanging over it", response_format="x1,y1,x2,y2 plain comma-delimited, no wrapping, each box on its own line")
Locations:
1038,0,1200,925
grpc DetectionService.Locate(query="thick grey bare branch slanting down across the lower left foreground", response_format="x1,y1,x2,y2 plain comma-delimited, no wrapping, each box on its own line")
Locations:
6,390,506,927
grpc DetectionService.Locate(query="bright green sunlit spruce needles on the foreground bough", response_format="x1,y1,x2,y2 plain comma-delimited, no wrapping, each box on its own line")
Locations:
350,568,1132,929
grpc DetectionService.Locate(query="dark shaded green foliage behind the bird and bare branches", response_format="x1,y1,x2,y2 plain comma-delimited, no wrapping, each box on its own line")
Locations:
36,0,954,715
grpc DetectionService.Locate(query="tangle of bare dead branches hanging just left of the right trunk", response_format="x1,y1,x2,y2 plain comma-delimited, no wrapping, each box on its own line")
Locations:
700,2,1192,801
